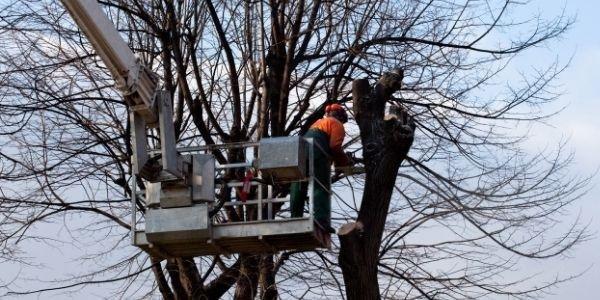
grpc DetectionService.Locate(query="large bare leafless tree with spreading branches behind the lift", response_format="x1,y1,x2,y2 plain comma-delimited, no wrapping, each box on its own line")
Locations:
0,0,587,299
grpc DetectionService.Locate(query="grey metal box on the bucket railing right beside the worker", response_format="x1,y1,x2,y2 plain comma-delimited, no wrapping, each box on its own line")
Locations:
258,136,308,181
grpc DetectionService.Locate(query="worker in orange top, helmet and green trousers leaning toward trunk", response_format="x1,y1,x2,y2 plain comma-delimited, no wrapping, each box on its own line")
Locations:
290,104,351,233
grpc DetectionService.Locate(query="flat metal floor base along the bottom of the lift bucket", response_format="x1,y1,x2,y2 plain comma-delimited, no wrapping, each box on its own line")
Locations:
135,218,331,258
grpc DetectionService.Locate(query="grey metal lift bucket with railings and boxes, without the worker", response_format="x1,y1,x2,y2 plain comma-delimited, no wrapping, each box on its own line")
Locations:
131,137,331,258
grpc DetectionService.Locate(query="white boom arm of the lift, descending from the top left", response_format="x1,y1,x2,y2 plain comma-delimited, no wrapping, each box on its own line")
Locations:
61,0,185,181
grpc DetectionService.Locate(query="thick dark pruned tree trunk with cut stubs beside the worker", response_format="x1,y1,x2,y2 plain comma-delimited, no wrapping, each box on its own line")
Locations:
338,70,415,300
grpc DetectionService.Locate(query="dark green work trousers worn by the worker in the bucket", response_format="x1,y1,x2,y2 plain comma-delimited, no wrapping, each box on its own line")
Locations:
290,129,331,224
